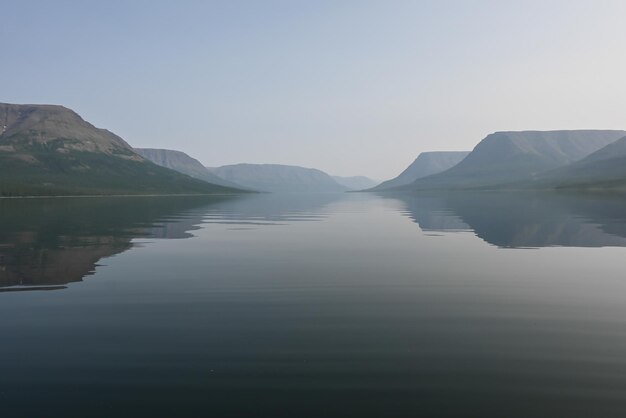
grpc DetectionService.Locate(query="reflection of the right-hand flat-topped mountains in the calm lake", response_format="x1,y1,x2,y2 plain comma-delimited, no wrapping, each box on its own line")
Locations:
394,193,626,247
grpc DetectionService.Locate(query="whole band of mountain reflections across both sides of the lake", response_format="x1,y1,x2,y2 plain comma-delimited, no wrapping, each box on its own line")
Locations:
0,193,626,291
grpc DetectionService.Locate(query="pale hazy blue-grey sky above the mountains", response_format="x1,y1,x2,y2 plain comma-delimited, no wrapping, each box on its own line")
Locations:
0,0,626,179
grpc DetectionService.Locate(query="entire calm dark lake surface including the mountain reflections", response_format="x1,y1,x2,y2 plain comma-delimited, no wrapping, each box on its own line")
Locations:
0,194,626,418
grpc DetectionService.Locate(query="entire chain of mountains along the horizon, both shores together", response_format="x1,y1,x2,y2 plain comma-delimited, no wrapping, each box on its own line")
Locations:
0,103,626,196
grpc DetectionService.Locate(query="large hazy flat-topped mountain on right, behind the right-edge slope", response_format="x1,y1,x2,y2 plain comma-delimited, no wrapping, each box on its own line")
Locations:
405,130,626,190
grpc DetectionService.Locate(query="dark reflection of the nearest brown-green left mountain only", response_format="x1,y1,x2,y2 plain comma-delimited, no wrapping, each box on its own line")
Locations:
0,197,236,287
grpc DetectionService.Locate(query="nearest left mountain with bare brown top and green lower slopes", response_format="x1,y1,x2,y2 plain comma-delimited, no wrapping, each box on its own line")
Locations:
0,103,241,196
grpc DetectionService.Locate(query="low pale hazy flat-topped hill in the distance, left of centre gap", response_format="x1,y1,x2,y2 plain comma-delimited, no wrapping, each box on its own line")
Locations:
211,164,347,193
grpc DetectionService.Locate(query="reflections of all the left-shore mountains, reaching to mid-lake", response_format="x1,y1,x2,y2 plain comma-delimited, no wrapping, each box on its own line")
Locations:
0,194,336,292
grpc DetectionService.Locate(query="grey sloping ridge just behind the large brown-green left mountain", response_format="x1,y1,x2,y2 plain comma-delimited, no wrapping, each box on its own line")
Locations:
135,148,243,188
